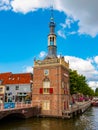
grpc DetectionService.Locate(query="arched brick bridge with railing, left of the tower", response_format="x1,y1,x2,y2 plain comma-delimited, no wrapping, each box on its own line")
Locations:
0,103,40,119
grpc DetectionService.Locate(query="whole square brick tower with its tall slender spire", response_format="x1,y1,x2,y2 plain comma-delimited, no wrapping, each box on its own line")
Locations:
32,10,70,117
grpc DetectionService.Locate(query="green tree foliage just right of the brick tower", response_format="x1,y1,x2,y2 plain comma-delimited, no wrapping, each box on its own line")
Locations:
69,69,94,96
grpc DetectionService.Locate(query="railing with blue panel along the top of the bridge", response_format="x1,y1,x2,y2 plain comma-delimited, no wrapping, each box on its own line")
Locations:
0,102,32,111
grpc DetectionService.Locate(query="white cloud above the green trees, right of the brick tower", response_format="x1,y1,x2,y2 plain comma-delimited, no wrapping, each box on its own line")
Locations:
65,56,98,89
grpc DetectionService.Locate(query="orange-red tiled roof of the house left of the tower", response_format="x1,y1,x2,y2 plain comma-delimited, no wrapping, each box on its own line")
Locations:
0,72,33,85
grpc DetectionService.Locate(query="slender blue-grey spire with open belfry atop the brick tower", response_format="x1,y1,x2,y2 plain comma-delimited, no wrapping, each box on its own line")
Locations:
46,8,57,58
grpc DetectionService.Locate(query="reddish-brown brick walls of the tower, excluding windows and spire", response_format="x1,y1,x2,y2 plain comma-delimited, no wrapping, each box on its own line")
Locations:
32,65,69,116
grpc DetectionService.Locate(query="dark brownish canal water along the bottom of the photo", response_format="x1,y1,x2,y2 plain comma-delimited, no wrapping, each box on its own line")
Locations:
0,107,98,130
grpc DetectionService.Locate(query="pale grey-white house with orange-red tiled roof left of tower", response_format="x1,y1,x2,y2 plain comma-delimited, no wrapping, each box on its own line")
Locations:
0,72,33,102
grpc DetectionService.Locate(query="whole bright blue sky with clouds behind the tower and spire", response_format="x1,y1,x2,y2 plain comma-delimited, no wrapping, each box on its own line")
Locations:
0,0,98,89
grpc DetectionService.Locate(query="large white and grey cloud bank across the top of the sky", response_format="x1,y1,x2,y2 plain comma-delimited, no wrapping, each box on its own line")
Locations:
0,0,98,38
